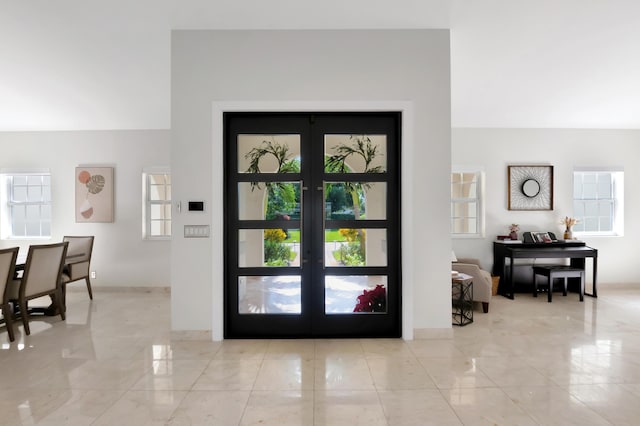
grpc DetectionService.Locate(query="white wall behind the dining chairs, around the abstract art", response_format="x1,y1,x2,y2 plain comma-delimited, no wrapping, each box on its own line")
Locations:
0,130,171,287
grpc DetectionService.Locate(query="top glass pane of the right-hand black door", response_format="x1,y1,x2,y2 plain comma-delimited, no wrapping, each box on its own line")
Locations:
324,135,387,173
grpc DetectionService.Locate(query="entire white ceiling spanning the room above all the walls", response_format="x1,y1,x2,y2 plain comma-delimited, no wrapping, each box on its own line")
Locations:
0,0,640,131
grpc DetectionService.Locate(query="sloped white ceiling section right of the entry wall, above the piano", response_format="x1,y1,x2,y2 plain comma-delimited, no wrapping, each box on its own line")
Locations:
449,0,640,129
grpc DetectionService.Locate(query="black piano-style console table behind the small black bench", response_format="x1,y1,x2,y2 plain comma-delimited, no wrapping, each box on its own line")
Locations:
493,241,598,299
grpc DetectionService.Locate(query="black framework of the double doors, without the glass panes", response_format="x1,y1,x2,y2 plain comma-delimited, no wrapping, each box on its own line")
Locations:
223,111,402,338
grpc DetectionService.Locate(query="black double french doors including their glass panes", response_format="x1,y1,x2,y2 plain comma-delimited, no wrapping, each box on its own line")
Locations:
224,112,401,338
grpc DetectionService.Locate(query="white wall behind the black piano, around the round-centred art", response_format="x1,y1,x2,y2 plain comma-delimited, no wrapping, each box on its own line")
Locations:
452,128,640,285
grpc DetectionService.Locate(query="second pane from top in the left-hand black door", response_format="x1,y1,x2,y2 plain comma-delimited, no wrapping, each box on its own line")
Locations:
238,181,300,220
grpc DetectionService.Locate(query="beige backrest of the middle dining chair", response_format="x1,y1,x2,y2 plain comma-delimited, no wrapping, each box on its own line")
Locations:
20,241,69,298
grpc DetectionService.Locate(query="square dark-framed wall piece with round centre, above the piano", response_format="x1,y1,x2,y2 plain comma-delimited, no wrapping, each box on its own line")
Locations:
507,166,553,210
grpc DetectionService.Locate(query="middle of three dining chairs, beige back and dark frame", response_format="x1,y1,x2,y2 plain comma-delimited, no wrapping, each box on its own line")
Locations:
9,241,69,335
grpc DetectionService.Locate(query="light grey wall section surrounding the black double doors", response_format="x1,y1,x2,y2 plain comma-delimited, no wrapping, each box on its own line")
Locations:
171,30,451,338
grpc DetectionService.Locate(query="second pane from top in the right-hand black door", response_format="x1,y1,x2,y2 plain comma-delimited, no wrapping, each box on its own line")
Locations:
324,182,387,220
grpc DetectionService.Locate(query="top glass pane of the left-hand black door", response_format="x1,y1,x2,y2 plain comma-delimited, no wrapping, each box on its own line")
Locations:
238,134,300,173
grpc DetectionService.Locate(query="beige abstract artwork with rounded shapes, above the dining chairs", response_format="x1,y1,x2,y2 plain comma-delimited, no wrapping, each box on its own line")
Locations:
75,167,113,223
